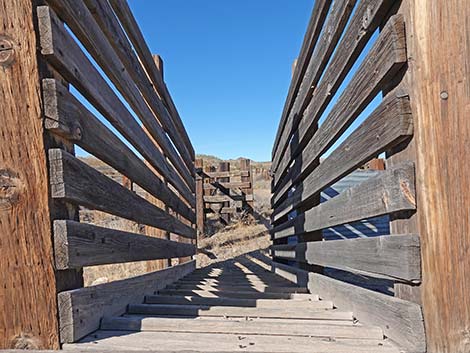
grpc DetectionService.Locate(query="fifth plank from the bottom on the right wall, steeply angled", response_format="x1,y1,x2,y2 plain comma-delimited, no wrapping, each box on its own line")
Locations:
274,16,407,194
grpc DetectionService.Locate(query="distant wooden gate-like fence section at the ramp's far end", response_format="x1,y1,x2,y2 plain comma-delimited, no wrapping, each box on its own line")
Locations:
196,159,254,233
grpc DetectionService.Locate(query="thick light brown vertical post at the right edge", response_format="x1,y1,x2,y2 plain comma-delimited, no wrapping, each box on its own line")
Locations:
400,0,470,353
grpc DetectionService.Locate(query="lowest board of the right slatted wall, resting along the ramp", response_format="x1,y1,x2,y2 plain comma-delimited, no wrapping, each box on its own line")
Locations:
273,264,426,353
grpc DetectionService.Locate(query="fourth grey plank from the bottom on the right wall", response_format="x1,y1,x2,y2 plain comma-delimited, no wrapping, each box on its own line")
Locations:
273,93,413,221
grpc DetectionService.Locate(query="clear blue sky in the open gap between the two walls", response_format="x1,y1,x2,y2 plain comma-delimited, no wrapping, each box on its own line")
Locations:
129,0,314,161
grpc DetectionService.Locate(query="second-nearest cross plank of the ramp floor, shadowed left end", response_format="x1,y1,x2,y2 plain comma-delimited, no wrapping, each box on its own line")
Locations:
100,316,383,340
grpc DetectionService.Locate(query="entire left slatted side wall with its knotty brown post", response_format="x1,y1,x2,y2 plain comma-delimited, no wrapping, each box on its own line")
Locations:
0,0,197,348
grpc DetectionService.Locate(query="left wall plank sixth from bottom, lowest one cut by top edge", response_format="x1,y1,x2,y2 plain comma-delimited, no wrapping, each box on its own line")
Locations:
41,0,194,192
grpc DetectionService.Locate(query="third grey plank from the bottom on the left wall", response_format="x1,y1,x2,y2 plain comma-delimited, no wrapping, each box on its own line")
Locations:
49,149,195,238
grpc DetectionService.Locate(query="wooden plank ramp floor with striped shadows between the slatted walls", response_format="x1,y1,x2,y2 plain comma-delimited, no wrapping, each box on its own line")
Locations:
64,257,399,353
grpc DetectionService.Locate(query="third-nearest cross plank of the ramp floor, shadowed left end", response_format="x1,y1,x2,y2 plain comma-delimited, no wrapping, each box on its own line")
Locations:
127,301,353,321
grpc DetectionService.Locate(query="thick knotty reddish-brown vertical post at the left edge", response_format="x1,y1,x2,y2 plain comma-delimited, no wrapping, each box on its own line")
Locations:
0,0,59,349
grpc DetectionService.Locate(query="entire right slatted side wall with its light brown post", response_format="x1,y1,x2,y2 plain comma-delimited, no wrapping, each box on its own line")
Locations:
271,0,470,352
